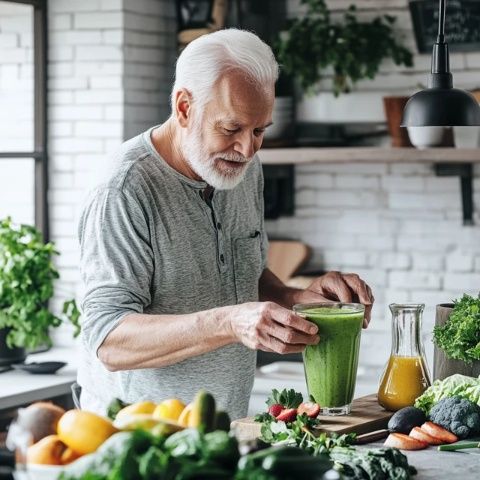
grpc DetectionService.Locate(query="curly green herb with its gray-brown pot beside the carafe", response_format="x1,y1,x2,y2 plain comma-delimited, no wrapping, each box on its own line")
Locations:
433,294,480,380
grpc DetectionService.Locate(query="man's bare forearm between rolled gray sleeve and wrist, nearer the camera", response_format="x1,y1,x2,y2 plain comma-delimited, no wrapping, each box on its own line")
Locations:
98,307,237,371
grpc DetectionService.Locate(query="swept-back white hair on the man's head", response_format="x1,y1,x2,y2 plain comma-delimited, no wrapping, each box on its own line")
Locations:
170,28,279,110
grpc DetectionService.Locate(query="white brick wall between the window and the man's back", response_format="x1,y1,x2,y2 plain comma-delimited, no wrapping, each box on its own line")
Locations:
48,0,176,344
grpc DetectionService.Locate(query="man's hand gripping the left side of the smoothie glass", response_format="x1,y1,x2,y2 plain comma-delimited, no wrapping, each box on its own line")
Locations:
229,302,319,354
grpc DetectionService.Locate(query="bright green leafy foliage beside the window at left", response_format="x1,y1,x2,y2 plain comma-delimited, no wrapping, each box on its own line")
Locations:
0,217,80,348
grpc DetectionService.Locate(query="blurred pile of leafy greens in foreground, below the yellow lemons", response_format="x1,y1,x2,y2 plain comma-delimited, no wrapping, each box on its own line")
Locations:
60,429,239,480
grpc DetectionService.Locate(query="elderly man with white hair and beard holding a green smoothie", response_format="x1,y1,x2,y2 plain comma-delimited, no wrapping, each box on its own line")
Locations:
78,29,373,418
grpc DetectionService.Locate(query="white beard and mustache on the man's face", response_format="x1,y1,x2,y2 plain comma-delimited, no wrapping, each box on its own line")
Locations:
181,118,253,190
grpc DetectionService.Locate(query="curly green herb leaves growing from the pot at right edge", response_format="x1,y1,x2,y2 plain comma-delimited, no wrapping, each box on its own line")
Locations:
433,294,480,363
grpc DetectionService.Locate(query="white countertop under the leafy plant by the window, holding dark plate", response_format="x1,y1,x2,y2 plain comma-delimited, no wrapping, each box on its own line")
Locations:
0,348,78,410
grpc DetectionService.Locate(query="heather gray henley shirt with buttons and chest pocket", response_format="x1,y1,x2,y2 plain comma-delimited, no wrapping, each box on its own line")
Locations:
78,129,267,418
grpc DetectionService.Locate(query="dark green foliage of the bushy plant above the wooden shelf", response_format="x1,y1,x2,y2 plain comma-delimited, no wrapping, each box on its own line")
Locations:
274,0,413,96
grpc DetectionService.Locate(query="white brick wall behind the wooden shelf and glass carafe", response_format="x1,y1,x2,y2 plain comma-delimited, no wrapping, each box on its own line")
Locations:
267,0,480,382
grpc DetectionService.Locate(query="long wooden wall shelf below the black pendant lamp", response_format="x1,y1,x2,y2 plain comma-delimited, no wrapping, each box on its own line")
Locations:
259,147,480,165
